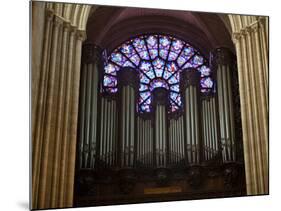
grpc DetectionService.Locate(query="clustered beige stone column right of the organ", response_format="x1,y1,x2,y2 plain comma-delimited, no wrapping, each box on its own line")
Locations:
233,17,268,195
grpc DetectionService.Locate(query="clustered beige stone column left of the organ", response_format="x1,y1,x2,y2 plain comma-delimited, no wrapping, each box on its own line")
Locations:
32,10,85,209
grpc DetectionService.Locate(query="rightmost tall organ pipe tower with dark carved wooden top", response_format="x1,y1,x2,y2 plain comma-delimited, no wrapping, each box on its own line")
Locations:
212,48,236,161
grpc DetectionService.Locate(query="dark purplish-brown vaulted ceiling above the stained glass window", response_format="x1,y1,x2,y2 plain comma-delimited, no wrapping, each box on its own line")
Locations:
87,6,234,57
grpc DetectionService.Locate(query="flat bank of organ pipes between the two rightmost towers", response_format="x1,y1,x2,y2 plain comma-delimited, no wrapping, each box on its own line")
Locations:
201,93,221,161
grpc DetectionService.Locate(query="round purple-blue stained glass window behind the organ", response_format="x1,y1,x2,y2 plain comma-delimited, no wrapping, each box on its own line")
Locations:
103,34,214,113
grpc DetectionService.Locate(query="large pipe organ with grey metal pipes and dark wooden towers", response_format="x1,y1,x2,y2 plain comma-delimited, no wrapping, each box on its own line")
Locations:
77,44,236,169
